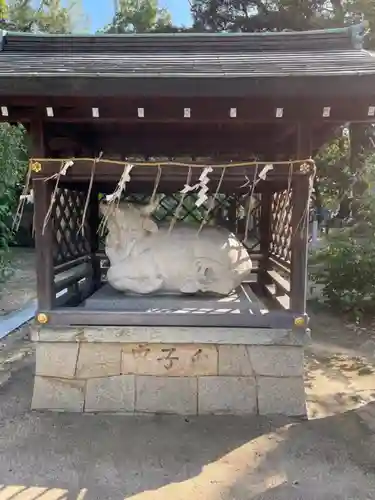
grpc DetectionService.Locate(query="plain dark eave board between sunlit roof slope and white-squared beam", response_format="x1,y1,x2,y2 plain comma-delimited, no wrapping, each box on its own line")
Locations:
0,73,374,100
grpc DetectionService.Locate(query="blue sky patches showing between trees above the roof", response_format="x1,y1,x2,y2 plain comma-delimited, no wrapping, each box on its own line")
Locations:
82,0,190,32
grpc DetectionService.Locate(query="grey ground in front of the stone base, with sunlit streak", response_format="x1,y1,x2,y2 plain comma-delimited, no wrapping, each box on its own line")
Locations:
0,359,375,500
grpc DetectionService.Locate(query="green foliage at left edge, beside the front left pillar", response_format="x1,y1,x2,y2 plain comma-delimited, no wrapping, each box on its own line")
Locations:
0,123,28,280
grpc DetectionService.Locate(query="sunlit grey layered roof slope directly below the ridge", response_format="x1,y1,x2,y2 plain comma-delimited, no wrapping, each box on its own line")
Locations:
0,50,375,78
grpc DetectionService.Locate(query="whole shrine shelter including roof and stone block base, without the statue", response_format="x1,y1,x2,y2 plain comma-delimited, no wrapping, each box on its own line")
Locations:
0,23,375,416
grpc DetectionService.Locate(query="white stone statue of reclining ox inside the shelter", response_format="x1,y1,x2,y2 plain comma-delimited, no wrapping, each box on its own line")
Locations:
100,202,252,295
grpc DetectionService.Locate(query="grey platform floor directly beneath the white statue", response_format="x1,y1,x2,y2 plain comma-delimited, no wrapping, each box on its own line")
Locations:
84,284,268,314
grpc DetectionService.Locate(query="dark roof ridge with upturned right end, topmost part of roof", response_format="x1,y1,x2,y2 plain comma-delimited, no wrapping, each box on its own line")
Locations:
0,22,368,53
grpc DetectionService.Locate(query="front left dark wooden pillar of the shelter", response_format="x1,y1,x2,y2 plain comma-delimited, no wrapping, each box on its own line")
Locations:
29,121,55,311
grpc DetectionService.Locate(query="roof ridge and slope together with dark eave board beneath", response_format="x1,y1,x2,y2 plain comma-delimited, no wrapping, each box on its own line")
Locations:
0,25,375,98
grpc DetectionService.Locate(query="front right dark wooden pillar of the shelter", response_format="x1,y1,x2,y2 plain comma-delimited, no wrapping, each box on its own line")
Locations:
290,124,311,314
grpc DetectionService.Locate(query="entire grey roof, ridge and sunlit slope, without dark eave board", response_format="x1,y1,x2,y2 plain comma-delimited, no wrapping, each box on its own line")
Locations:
0,25,375,78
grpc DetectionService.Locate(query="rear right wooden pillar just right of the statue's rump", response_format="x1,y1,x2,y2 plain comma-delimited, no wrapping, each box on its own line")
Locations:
258,191,272,285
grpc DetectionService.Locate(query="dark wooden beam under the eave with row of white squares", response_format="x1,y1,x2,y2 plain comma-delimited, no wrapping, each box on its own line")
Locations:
0,95,375,124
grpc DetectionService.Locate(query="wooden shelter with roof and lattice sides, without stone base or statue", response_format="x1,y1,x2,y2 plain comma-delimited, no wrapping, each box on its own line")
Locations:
0,24,375,328
